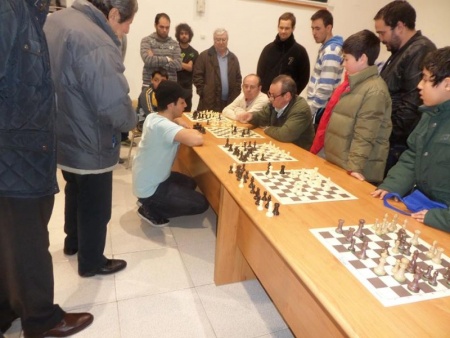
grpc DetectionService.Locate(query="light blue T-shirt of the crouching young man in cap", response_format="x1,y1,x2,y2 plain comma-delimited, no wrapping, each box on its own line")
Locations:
132,114,183,198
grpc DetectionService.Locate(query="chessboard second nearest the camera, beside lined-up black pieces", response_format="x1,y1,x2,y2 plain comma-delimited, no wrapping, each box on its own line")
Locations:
250,168,357,205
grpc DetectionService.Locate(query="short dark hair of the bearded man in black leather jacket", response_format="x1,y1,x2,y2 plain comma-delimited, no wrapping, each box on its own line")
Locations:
373,0,416,29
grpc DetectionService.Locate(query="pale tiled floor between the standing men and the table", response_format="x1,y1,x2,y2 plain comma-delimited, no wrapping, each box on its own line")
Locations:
5,148,293,338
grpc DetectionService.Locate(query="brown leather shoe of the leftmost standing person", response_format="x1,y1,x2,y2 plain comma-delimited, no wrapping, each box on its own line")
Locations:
25,312,94,338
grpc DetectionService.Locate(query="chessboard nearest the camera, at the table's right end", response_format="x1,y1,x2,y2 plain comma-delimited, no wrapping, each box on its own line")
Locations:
310,216,450,307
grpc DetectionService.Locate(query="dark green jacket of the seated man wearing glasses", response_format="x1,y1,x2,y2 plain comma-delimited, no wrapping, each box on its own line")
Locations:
250,96,314,151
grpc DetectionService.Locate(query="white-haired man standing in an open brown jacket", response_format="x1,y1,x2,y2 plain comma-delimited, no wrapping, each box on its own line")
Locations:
193,28,242,112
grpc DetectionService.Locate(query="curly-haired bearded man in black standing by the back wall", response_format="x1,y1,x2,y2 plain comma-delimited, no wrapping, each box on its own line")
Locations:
175,23,198,111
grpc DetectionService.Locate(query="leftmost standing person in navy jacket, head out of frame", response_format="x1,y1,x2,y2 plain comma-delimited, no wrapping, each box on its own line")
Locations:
0,0,94,337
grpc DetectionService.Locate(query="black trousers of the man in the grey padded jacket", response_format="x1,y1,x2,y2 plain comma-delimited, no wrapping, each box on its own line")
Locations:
62,170,112,273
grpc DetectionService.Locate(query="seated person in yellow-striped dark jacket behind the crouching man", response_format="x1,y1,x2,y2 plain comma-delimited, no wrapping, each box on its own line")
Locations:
137,68,169,131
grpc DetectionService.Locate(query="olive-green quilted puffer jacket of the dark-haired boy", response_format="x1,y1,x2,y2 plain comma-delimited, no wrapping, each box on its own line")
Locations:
324,66,392,183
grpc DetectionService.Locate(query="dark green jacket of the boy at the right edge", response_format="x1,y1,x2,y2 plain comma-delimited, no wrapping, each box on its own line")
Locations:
379,101,450,232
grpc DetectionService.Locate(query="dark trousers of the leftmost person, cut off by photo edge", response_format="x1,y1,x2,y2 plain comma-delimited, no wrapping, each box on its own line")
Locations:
0,195,64,335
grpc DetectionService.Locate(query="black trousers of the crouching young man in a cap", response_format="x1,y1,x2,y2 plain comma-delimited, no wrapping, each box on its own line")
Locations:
139,172,209,218
